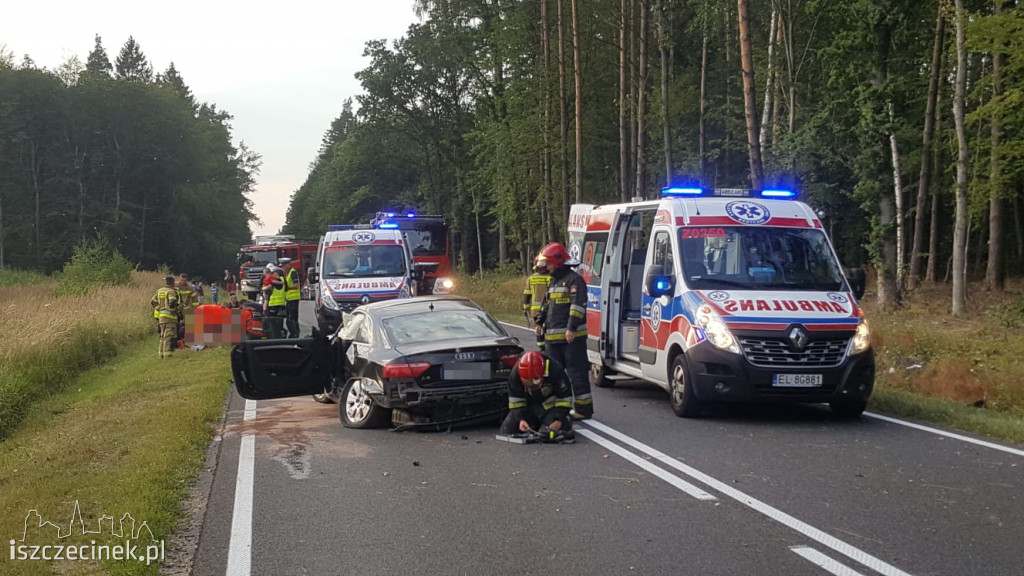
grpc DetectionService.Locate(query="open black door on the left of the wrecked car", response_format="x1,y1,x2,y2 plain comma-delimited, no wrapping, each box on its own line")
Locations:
231,336,331,400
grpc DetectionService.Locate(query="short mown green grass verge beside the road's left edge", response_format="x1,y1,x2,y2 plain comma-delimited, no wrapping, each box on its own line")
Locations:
0,336,229,575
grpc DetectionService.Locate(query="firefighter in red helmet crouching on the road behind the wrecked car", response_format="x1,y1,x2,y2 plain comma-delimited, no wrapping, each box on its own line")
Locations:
501,351,575,443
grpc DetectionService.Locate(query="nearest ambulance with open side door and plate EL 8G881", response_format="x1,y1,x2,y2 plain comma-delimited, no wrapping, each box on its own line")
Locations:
570,188,874,418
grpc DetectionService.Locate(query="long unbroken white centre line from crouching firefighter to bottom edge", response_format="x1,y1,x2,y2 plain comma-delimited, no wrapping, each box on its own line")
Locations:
583,420,909,576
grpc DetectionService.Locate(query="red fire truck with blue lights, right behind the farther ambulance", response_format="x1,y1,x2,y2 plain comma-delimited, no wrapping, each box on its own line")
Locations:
370,211,455,295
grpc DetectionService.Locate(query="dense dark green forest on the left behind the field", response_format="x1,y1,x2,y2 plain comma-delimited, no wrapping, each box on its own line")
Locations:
0,36,260,278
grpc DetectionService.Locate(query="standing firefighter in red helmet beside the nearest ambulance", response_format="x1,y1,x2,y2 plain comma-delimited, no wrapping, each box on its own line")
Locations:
536,242,594,420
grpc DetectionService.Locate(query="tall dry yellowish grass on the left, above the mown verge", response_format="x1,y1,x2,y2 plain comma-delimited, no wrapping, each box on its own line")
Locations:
0,273,163,439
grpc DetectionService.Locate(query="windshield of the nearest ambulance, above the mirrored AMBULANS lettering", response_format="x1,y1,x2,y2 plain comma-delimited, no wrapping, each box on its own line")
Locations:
679,227,846,292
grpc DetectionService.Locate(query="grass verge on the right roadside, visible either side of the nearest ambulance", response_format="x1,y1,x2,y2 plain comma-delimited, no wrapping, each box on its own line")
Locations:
458,273,1024,444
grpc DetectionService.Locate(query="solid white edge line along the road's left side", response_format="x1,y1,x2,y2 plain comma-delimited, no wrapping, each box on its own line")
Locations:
225,400,256,576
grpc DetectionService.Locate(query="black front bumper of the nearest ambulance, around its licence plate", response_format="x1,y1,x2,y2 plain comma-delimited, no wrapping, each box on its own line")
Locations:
686,343,874,403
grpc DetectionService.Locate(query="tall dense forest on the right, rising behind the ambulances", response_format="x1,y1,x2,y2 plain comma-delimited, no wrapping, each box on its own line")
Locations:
286,0,1024,314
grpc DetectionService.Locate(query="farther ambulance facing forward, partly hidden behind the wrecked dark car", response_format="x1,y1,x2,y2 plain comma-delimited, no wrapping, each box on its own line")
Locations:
309,224,423,334
